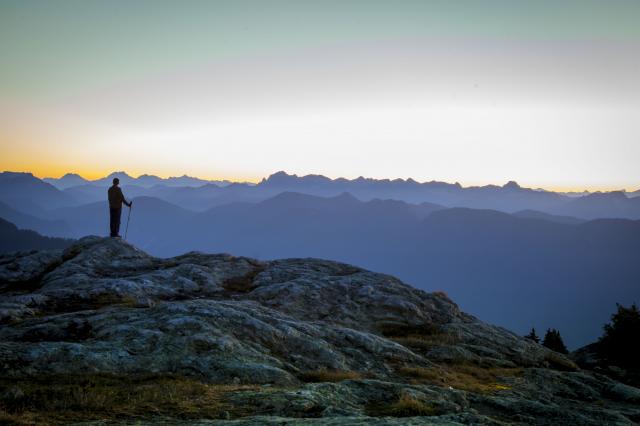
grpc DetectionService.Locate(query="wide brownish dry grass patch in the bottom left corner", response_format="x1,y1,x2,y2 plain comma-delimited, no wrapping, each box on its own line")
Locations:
0,376,257,425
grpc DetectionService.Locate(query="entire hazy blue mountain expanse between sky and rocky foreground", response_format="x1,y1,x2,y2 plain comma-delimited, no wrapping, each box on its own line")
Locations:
0,173,640,347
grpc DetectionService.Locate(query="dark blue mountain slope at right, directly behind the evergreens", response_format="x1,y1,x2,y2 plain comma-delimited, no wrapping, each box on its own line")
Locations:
416,209,640,347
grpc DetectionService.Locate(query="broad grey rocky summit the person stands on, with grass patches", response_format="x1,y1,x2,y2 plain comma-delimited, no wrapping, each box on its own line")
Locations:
0,237,640,425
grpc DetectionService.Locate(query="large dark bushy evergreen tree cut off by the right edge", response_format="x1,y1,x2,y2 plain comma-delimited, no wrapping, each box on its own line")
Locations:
597,303,640,370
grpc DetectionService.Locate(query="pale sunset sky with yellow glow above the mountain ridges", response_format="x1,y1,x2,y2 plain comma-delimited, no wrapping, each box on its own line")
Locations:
0,0,640,190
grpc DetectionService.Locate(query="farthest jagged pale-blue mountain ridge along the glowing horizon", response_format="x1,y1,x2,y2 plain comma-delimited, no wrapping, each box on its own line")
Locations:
8,172,640,219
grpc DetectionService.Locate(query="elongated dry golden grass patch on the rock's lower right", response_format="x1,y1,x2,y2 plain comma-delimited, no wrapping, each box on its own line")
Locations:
397,364,522,393
